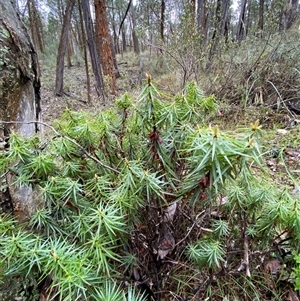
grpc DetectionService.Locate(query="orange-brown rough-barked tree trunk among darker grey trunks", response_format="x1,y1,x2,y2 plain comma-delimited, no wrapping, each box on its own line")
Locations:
94,0,117,94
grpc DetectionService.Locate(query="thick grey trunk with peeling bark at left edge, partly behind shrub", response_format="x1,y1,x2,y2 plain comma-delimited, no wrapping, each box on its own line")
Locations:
0,0,40,220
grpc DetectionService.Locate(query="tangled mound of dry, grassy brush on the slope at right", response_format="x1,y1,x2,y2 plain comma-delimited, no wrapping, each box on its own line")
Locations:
199,28,300,114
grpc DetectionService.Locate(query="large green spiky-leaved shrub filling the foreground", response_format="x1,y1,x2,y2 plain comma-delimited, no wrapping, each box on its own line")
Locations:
0,76,300,300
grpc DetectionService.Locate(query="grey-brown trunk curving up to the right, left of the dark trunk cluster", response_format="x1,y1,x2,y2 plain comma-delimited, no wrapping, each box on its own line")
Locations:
55,0,75,96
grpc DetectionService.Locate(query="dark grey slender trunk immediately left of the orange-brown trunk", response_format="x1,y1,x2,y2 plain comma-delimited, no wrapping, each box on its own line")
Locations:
81,0,105,101
